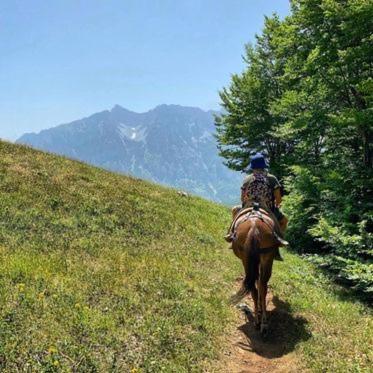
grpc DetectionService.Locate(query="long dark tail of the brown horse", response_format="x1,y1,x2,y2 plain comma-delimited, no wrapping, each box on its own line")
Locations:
231,220,260,303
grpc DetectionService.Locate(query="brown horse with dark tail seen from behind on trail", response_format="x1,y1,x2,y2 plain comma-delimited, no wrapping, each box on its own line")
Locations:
232,209,280,334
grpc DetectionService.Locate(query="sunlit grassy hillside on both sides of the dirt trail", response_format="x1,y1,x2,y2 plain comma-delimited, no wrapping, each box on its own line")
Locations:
0,142,372,372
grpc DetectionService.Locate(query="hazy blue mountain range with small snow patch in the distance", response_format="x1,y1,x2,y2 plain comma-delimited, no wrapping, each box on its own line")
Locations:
17,105,242,204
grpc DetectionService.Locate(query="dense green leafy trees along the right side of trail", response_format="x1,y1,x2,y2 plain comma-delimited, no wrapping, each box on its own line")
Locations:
216,0,373,296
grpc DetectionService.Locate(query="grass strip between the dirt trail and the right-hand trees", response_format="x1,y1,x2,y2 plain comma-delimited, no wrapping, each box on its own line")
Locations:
272,248,373,372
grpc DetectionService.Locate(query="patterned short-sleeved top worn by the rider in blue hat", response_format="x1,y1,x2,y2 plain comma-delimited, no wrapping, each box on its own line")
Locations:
241,171,281,211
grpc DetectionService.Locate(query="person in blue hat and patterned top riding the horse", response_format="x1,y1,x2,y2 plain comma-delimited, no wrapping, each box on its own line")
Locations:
225,153,288,260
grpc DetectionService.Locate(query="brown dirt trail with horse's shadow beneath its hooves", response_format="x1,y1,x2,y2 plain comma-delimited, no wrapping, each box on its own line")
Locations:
221,280,309,373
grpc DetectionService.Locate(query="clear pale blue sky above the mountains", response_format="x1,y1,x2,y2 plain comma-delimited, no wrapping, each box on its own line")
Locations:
0,0,289,139
